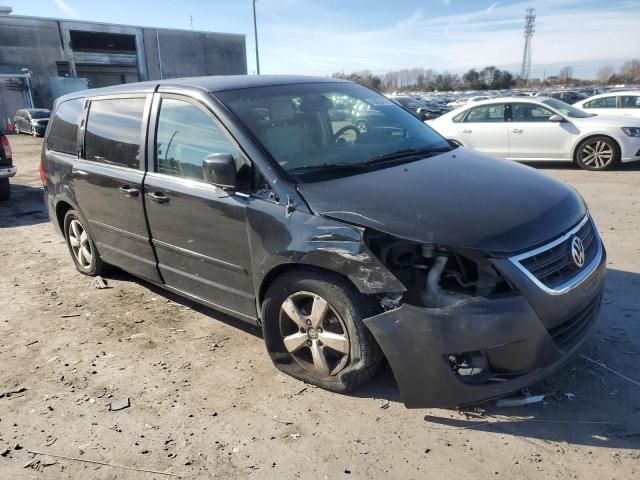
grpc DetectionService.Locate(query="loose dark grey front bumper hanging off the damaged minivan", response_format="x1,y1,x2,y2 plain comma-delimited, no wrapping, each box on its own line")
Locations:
364,242,606,408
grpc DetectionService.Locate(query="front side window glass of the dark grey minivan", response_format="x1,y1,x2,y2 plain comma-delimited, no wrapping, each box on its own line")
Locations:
156,98,240,180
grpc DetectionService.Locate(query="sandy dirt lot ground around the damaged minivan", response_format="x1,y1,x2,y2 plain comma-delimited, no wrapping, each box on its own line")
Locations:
0,135,640,479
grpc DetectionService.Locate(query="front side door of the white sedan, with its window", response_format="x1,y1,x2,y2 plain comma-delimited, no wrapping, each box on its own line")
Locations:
508,103,572,160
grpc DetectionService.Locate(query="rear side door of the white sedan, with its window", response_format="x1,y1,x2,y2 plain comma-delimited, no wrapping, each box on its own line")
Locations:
456,103,508,158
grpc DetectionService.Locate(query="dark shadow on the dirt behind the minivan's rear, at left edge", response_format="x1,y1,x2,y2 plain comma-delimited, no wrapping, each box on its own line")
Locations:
0,183,49,228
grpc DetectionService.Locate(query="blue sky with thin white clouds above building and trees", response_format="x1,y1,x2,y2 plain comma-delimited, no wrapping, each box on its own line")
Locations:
6,0,640,78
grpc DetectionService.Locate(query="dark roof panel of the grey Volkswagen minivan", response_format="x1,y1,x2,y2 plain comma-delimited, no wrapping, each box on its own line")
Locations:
58,75,351,102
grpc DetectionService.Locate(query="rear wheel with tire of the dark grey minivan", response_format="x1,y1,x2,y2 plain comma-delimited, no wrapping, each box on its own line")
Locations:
64,210,105,277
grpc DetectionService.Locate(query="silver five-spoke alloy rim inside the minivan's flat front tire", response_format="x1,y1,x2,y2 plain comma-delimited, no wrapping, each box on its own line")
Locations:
280,292,350,376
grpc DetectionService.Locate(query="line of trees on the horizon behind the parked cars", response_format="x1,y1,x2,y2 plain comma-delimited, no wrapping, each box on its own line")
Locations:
331,59,640,92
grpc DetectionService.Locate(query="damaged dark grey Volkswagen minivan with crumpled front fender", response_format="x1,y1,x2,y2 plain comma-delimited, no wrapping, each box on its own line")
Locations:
41,76,606,407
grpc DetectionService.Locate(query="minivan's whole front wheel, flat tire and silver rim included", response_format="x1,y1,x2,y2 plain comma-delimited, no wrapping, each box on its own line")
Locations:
262,269,382,393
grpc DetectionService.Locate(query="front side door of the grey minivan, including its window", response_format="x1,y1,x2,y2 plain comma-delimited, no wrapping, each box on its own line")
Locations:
144,94,256,318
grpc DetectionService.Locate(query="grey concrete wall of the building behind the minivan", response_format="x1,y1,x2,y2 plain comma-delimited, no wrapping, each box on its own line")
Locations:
0,15,247,121
